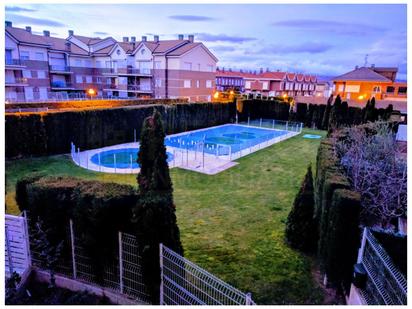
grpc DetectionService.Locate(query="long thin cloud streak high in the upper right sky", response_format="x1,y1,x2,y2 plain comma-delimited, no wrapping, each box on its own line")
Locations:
271,19,386,35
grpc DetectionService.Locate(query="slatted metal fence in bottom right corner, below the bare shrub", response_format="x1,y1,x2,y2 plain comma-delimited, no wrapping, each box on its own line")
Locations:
358,228,407,305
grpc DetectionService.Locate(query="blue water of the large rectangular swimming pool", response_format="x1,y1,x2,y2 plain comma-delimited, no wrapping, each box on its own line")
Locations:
165,124,288,155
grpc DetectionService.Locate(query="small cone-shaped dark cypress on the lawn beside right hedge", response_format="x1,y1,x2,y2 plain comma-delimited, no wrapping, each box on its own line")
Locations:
285,165,317,252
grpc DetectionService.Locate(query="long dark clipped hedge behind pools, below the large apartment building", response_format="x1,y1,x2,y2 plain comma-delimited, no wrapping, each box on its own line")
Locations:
5,103,236,158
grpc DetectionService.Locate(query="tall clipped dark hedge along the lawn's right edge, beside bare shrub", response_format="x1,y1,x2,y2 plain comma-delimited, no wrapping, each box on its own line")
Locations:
315,139,361,288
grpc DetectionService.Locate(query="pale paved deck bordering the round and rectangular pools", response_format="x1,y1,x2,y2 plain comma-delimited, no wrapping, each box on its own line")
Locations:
71,125,300,175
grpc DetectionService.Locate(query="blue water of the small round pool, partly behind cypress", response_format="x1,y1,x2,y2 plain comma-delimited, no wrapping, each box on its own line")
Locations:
91,148,173,168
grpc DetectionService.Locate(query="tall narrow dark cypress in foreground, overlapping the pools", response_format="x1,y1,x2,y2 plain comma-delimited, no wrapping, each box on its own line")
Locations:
132,110,183,304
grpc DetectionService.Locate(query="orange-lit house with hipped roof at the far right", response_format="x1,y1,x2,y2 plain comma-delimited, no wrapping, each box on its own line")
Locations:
333,65,407,102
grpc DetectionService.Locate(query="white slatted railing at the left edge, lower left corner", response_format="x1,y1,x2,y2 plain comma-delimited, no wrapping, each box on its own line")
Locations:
5,215,31,277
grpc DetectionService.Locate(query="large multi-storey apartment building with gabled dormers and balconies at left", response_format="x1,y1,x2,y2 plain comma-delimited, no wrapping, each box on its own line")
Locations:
5,22,218,101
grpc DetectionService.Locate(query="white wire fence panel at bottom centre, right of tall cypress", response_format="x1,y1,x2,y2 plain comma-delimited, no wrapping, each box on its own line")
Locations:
159,244,256,305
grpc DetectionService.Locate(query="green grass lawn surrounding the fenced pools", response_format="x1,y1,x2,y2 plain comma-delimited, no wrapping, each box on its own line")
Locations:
6,130,325,304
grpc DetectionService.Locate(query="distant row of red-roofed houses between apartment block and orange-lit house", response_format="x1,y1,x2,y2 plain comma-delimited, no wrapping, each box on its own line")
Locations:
216,69,317,97
